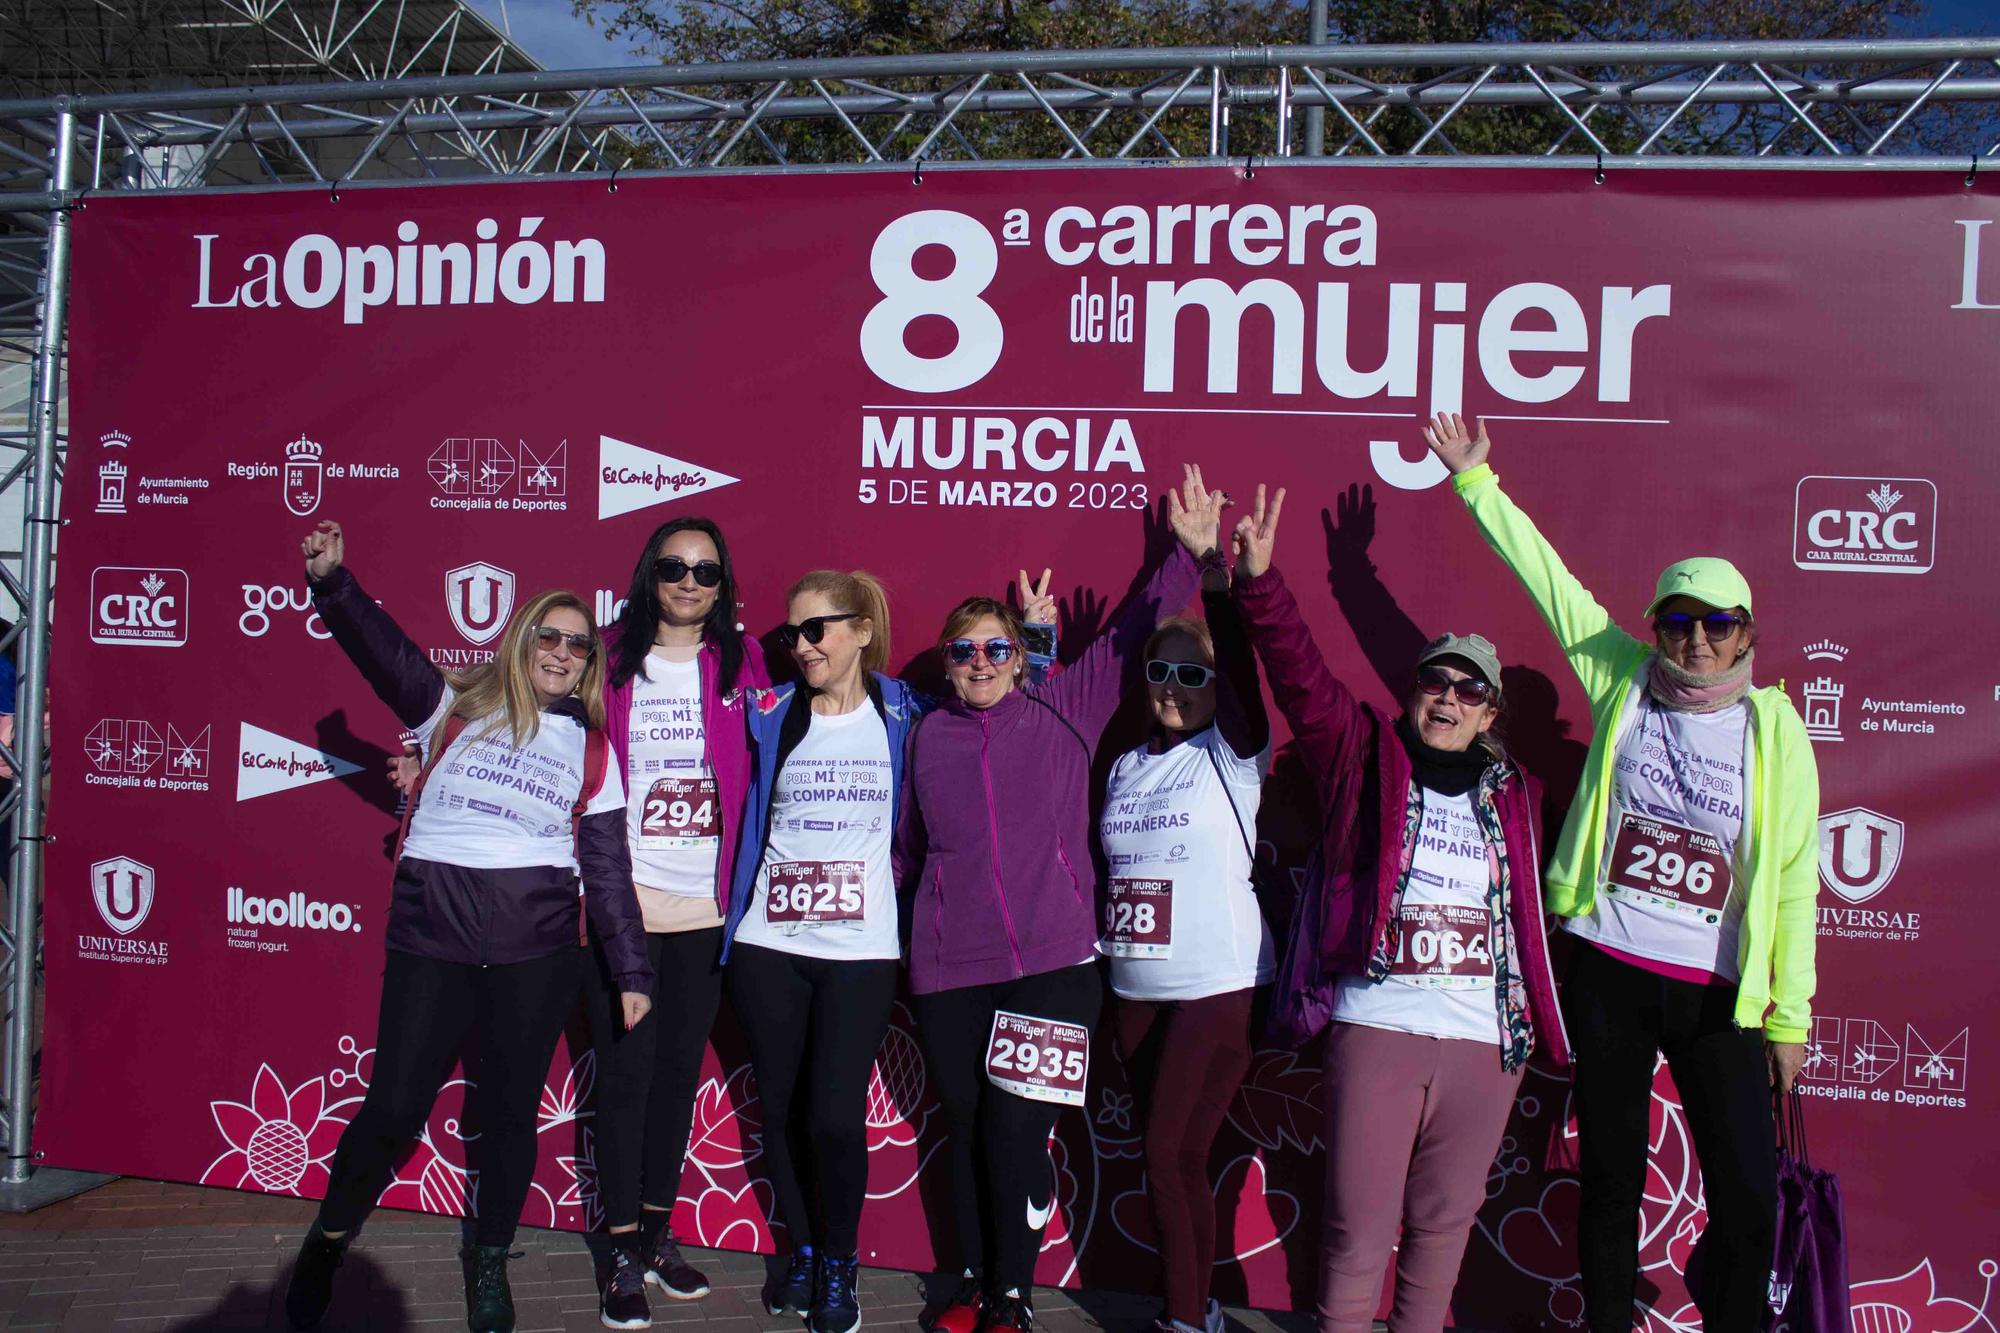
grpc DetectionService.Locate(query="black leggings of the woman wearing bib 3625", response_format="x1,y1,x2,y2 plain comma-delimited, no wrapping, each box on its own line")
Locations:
726,943,902,1259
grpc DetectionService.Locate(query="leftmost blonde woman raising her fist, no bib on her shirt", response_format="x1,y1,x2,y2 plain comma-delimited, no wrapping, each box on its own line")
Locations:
284,522,652,1333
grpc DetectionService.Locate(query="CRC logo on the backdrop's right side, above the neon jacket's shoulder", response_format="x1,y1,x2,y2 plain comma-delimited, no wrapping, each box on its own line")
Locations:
1792,476,1938,574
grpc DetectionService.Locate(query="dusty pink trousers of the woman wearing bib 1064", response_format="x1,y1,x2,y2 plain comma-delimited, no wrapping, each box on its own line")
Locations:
1320,1023,1520,1333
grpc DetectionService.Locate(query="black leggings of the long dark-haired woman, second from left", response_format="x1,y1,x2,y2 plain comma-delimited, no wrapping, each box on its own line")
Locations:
584,927,722,1227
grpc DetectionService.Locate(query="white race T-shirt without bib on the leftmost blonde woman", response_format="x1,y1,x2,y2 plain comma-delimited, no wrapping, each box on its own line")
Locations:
402,687,624,871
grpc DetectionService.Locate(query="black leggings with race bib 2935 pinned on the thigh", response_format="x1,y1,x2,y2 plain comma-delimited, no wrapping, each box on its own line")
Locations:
912,963,1104,1297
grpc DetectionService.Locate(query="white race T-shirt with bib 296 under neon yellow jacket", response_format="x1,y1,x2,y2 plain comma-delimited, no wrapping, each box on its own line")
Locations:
1568,691,1750,981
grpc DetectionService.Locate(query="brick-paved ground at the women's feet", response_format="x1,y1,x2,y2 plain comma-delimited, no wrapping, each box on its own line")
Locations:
0,1179,1336,1333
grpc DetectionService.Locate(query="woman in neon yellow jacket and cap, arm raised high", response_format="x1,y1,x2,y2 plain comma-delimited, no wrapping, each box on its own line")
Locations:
1426,414,1820,1333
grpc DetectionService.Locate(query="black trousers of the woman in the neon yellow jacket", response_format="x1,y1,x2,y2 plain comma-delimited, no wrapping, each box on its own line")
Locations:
1562,945,1778,1333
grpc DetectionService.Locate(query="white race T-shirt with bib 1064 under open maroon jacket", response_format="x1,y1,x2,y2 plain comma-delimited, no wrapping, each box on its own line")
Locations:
1334,789,1496,1045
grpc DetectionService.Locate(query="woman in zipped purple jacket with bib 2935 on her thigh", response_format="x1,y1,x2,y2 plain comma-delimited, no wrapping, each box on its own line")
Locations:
900,472,1228,1333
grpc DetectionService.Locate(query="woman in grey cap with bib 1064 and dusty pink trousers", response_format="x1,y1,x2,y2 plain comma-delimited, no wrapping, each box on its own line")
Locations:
1234,486,1568,1333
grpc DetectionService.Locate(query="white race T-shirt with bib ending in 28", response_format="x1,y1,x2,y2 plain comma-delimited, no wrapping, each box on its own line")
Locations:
1098,727,1276,1001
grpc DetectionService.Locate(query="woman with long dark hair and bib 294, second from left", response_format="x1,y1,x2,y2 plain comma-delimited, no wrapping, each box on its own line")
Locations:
584,516,770,1329
